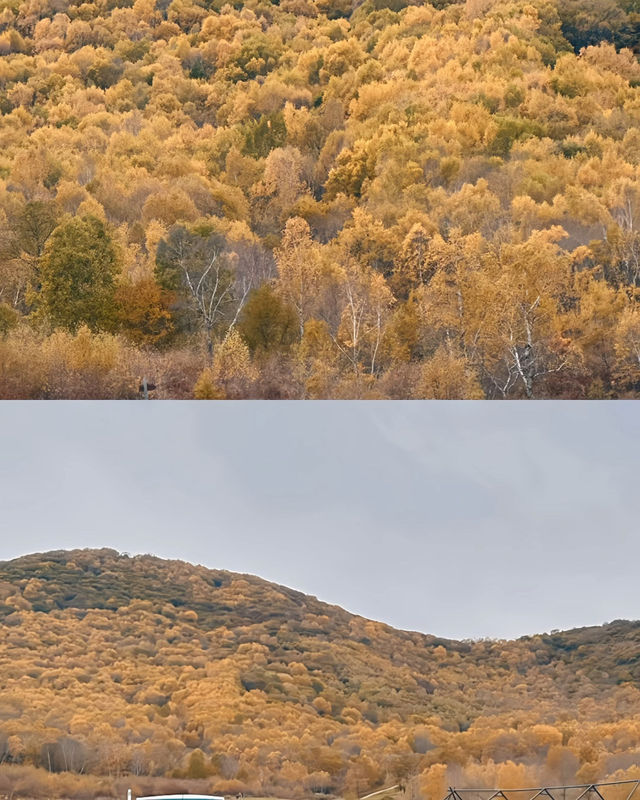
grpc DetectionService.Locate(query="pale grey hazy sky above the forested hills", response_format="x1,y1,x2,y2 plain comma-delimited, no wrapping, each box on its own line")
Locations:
0,401,640,638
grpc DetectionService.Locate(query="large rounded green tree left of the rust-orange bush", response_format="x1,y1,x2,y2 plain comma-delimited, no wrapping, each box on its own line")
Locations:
36,215,120,331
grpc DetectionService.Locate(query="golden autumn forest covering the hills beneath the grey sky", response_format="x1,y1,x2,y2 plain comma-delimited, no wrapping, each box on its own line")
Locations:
0,549,640,800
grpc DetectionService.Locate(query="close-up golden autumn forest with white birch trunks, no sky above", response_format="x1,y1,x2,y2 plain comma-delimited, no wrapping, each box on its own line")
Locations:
0,0,640,398
